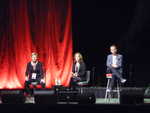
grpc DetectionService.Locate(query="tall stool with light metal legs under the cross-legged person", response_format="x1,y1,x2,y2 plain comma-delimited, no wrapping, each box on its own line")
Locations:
105,73,120,102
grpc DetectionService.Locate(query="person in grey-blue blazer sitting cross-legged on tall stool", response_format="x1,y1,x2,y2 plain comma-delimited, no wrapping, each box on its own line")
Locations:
106,45,126,90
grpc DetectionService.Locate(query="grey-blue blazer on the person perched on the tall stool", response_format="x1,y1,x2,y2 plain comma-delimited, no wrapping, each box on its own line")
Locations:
106,54,123,73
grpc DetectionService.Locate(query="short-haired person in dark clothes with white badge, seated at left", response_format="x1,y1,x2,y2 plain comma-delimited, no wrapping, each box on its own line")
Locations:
25,53,45,90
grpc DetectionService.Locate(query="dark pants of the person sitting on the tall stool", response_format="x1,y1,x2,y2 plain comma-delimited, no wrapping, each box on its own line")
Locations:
109,68,123,89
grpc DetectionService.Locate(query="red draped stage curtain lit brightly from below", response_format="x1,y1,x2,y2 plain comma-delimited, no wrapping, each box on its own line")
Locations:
0,0,72,89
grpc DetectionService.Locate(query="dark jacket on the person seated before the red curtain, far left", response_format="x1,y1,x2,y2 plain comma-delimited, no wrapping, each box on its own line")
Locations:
25,61,44,79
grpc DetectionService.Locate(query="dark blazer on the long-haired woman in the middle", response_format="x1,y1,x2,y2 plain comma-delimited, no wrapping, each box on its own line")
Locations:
72,62,86,79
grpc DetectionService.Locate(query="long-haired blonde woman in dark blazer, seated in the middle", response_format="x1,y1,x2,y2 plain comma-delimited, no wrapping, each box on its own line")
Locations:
70,53,86,88
